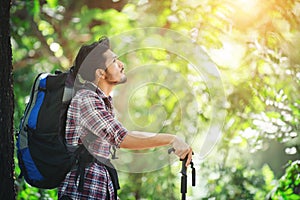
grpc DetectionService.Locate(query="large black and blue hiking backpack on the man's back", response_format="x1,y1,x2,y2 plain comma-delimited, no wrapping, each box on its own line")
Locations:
17,68,75,189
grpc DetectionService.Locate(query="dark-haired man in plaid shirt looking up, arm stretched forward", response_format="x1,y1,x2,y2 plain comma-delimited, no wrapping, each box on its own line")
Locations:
58,37,192,200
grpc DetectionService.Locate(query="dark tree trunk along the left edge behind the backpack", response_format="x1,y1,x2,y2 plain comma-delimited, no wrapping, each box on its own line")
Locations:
0,0,16,200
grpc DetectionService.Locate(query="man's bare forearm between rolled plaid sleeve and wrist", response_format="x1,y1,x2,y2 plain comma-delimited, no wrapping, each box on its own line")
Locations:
120,131,175,150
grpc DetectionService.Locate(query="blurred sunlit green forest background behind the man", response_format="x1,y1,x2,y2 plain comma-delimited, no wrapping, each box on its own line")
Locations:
2,0,300,200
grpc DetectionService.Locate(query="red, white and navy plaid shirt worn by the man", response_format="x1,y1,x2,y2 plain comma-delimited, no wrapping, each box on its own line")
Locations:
58,83,127,200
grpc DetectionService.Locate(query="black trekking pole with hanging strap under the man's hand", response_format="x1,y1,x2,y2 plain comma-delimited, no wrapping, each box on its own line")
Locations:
168,148,196,200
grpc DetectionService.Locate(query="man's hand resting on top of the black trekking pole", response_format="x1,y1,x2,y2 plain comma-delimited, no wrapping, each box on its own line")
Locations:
172,136,193,166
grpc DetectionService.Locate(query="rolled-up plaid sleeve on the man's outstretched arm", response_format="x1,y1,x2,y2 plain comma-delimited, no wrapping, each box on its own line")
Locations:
80,92,128,148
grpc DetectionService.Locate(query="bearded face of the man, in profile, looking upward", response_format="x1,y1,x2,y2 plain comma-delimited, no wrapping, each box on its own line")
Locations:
104,49,127,84
